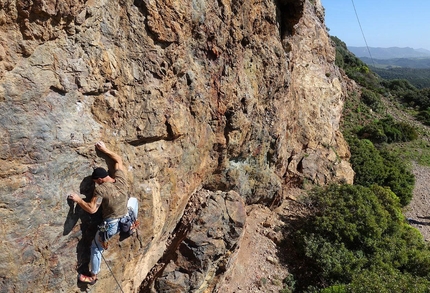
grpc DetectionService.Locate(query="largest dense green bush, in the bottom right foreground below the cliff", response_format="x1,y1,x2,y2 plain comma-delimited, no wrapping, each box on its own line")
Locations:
294,185,430,293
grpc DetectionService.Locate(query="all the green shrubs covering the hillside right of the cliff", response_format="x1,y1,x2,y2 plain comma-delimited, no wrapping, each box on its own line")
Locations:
282,37,430,293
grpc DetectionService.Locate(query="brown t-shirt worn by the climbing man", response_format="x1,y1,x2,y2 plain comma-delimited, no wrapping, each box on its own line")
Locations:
94,170,128,220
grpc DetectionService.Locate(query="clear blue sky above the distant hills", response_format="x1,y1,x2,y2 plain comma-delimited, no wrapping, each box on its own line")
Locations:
321,0,430,50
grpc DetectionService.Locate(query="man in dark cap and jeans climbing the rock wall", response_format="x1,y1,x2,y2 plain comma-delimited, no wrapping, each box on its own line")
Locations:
69,142,128,285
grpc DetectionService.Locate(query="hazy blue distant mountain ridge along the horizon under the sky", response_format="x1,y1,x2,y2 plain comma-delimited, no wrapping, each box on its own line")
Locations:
348,46,430,59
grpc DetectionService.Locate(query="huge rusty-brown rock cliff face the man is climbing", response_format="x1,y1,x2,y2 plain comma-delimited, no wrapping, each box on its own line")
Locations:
0,0,353,292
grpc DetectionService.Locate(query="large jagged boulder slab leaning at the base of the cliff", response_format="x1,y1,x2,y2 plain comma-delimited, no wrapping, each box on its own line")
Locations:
141,190,246,292
